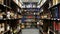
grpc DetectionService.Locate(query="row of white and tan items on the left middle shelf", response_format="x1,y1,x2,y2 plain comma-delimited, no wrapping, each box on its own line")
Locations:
0,12,17,19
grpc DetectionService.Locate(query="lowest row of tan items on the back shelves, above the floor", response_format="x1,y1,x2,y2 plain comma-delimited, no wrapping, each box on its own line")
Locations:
21,22,43,29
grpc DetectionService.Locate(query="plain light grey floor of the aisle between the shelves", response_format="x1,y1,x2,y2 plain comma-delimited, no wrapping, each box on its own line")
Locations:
18,29,43,34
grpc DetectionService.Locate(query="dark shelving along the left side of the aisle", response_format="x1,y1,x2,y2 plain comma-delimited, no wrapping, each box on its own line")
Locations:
0,0,21,34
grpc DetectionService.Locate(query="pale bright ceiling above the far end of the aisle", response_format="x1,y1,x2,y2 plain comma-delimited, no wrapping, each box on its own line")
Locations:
20,0,44,7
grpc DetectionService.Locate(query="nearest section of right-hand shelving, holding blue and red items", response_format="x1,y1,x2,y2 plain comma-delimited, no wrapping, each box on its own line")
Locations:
48,0,60,34
